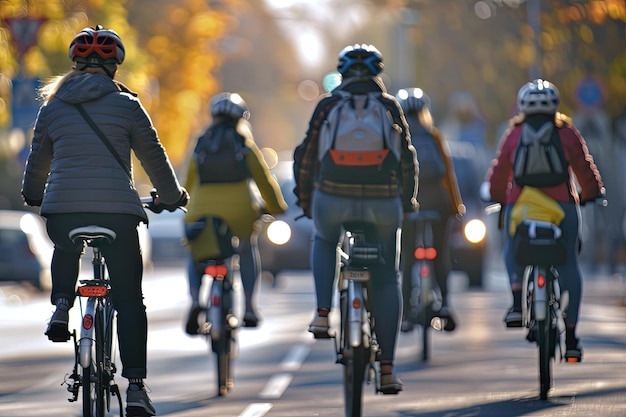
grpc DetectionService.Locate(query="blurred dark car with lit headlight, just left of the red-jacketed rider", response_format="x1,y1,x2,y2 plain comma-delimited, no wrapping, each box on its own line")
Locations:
448,141,487,287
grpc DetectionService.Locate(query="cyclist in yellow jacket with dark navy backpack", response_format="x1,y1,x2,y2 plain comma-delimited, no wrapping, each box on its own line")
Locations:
185,92,287,335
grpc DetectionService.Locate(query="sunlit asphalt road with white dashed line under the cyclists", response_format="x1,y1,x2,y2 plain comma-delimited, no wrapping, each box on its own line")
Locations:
0,258,626,417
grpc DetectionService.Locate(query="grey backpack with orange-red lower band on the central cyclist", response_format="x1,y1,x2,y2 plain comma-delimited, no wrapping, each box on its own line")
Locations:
318,91,400,184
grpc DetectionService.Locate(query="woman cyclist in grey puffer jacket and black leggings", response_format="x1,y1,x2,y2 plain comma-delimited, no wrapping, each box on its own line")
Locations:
21,25,189,417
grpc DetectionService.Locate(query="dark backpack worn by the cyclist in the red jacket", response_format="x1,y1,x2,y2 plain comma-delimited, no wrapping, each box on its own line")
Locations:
513,123,569,187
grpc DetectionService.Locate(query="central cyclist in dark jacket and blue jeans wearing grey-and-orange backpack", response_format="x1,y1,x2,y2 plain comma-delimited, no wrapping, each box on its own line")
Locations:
293,44,418,394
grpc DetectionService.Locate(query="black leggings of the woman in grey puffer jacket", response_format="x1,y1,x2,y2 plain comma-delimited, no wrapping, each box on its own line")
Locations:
46,213,148,378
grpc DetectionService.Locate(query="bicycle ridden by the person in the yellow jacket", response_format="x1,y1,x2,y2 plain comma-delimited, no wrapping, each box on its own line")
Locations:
185,216,240,396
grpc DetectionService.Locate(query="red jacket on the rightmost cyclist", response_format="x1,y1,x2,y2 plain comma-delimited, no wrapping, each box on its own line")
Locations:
489,119,604,204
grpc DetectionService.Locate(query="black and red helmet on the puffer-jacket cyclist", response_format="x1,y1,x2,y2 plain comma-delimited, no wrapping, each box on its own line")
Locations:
68,25,125,65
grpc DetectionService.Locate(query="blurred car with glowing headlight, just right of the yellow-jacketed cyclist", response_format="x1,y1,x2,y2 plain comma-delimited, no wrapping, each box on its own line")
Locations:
259,161,314,279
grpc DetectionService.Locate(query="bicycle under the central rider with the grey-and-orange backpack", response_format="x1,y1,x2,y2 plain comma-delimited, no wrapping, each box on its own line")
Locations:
335,222,383,417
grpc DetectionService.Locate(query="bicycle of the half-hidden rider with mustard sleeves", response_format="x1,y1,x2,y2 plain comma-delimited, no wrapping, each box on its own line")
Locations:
405,210,448,361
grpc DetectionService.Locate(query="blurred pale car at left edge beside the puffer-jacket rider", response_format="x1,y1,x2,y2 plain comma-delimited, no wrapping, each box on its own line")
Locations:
0,210,53,291
